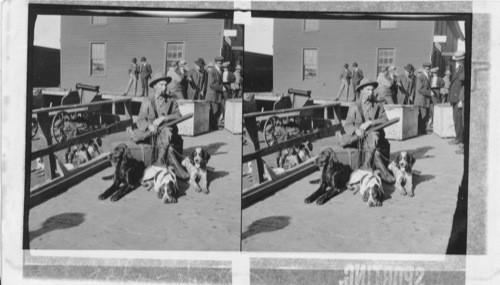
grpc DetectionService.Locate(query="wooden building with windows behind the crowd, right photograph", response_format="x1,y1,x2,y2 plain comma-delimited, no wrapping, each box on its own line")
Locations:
273,19,464,99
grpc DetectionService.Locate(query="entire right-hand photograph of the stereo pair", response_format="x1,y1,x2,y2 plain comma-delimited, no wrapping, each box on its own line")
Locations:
241,12,471,254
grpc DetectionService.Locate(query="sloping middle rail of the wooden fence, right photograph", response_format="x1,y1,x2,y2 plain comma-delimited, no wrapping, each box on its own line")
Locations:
241,125,339,163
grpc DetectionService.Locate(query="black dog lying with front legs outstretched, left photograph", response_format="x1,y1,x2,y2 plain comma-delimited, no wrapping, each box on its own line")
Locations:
99,144,146,202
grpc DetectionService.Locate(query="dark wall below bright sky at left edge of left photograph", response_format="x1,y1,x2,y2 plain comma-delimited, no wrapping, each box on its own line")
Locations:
32,46,61,87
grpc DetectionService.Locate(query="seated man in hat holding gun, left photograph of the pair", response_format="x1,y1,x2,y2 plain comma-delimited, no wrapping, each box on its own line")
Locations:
135,73,183,167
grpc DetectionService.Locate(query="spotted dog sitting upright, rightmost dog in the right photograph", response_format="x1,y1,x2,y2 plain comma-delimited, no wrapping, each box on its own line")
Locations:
388,151,415,197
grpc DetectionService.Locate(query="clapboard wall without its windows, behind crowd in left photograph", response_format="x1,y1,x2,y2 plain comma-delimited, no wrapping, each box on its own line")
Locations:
61,16,224,94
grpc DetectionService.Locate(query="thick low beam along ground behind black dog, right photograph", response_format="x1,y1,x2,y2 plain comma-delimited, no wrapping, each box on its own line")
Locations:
241,157,318,209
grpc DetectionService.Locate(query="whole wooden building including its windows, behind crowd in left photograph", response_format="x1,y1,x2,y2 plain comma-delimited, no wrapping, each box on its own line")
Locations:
61,16,243,94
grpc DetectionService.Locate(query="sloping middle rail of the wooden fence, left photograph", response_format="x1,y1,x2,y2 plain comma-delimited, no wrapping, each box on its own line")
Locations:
31,120,133,160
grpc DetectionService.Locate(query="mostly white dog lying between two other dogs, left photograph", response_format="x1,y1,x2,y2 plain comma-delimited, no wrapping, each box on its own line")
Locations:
141,166,179,204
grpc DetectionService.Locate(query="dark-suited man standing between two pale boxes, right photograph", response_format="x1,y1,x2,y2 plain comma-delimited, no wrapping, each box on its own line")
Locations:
415,62,433,134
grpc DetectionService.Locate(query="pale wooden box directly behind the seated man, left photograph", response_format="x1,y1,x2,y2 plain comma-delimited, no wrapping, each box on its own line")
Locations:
177,100,210,136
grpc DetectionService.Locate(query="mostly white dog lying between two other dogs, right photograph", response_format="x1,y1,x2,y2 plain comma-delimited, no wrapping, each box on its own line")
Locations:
348,169,385,207
